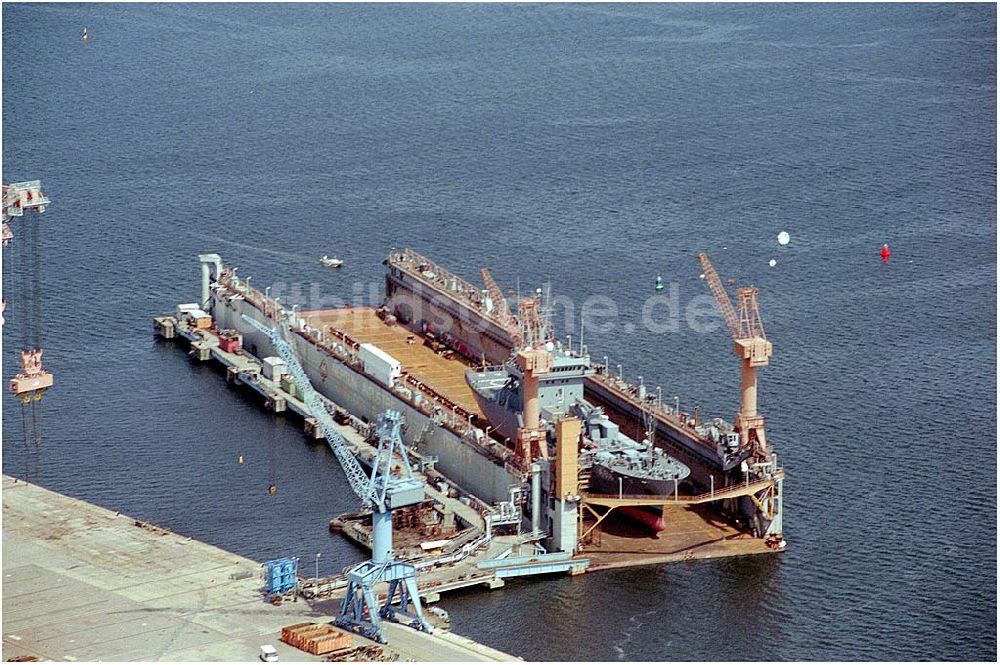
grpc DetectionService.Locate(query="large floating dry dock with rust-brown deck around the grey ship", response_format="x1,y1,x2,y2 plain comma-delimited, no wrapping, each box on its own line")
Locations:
154,252,784,598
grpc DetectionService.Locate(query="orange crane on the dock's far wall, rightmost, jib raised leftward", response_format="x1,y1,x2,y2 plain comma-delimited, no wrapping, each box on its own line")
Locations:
698,253,773,457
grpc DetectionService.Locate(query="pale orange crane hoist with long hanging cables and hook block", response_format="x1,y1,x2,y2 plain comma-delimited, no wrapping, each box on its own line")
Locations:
0,180,53,472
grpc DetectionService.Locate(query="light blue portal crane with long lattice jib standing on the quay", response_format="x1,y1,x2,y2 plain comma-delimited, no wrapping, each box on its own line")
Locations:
243,314,432,644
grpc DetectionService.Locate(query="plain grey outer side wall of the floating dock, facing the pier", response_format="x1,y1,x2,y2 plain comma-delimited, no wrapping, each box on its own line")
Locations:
212,296,519,503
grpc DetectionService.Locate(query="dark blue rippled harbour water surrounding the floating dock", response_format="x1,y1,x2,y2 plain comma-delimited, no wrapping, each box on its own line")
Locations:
3,4,997,660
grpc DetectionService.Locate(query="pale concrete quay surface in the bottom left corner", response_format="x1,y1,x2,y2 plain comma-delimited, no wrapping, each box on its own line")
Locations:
2,476,517,662
